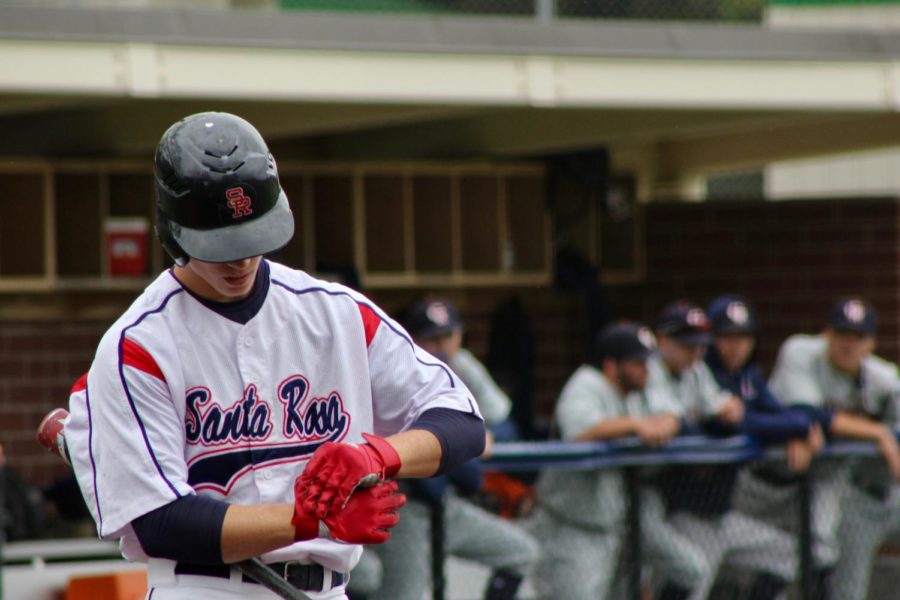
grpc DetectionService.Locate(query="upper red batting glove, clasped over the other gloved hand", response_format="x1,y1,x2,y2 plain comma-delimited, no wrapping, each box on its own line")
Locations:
296,433,400,519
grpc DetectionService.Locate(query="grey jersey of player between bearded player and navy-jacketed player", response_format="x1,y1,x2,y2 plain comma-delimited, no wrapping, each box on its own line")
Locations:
646,356,730,422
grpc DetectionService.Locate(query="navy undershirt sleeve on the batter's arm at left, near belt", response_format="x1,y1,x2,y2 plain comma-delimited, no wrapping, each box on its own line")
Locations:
131,495,228,564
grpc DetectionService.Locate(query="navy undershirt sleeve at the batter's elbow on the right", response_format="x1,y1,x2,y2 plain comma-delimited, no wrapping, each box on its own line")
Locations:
410,408,485,475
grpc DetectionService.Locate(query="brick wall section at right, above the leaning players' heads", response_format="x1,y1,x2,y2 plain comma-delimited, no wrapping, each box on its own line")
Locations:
608,199,900,366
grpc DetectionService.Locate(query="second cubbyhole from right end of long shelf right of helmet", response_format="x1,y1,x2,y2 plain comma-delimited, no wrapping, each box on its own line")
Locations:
460,176,500,271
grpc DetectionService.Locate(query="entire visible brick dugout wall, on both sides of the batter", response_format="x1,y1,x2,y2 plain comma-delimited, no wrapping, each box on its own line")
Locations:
7,200,900,484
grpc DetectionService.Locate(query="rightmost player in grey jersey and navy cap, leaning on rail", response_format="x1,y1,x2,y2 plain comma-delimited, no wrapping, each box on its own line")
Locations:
737,297,900,600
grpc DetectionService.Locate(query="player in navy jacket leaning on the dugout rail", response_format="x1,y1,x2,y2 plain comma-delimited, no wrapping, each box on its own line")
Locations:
660,296,804,600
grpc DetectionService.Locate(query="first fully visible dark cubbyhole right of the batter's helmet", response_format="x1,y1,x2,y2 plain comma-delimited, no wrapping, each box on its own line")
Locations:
313,175,354,271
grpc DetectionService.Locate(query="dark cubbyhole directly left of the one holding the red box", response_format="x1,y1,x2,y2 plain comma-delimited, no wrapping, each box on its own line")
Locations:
54,173,103,277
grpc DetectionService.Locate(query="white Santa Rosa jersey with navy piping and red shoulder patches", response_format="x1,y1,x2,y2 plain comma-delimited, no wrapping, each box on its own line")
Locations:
66,262,479,572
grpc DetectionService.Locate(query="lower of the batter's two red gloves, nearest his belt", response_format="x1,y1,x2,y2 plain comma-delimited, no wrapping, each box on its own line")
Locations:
291,477,406,544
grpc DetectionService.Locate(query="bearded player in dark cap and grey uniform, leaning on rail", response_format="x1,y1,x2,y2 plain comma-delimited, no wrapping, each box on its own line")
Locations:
529,323,678,598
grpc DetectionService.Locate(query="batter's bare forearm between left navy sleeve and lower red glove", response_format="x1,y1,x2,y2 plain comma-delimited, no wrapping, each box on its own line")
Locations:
222,504,295,563
